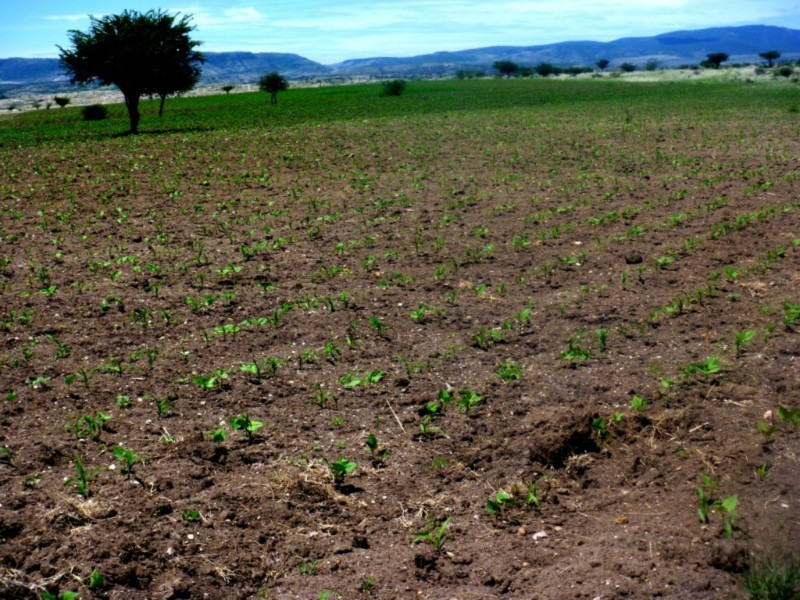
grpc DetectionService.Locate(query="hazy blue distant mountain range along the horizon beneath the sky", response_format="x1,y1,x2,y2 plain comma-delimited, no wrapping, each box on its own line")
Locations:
0,25,800,91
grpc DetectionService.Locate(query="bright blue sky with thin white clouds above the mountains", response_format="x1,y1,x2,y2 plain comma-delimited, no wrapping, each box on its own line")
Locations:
0,0,800,64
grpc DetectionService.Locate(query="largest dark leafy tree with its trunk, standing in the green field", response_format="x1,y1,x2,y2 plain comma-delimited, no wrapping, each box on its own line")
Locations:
59,10,205,133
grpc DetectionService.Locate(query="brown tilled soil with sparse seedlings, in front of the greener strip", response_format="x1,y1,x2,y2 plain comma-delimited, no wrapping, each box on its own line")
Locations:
0,96,800,599
